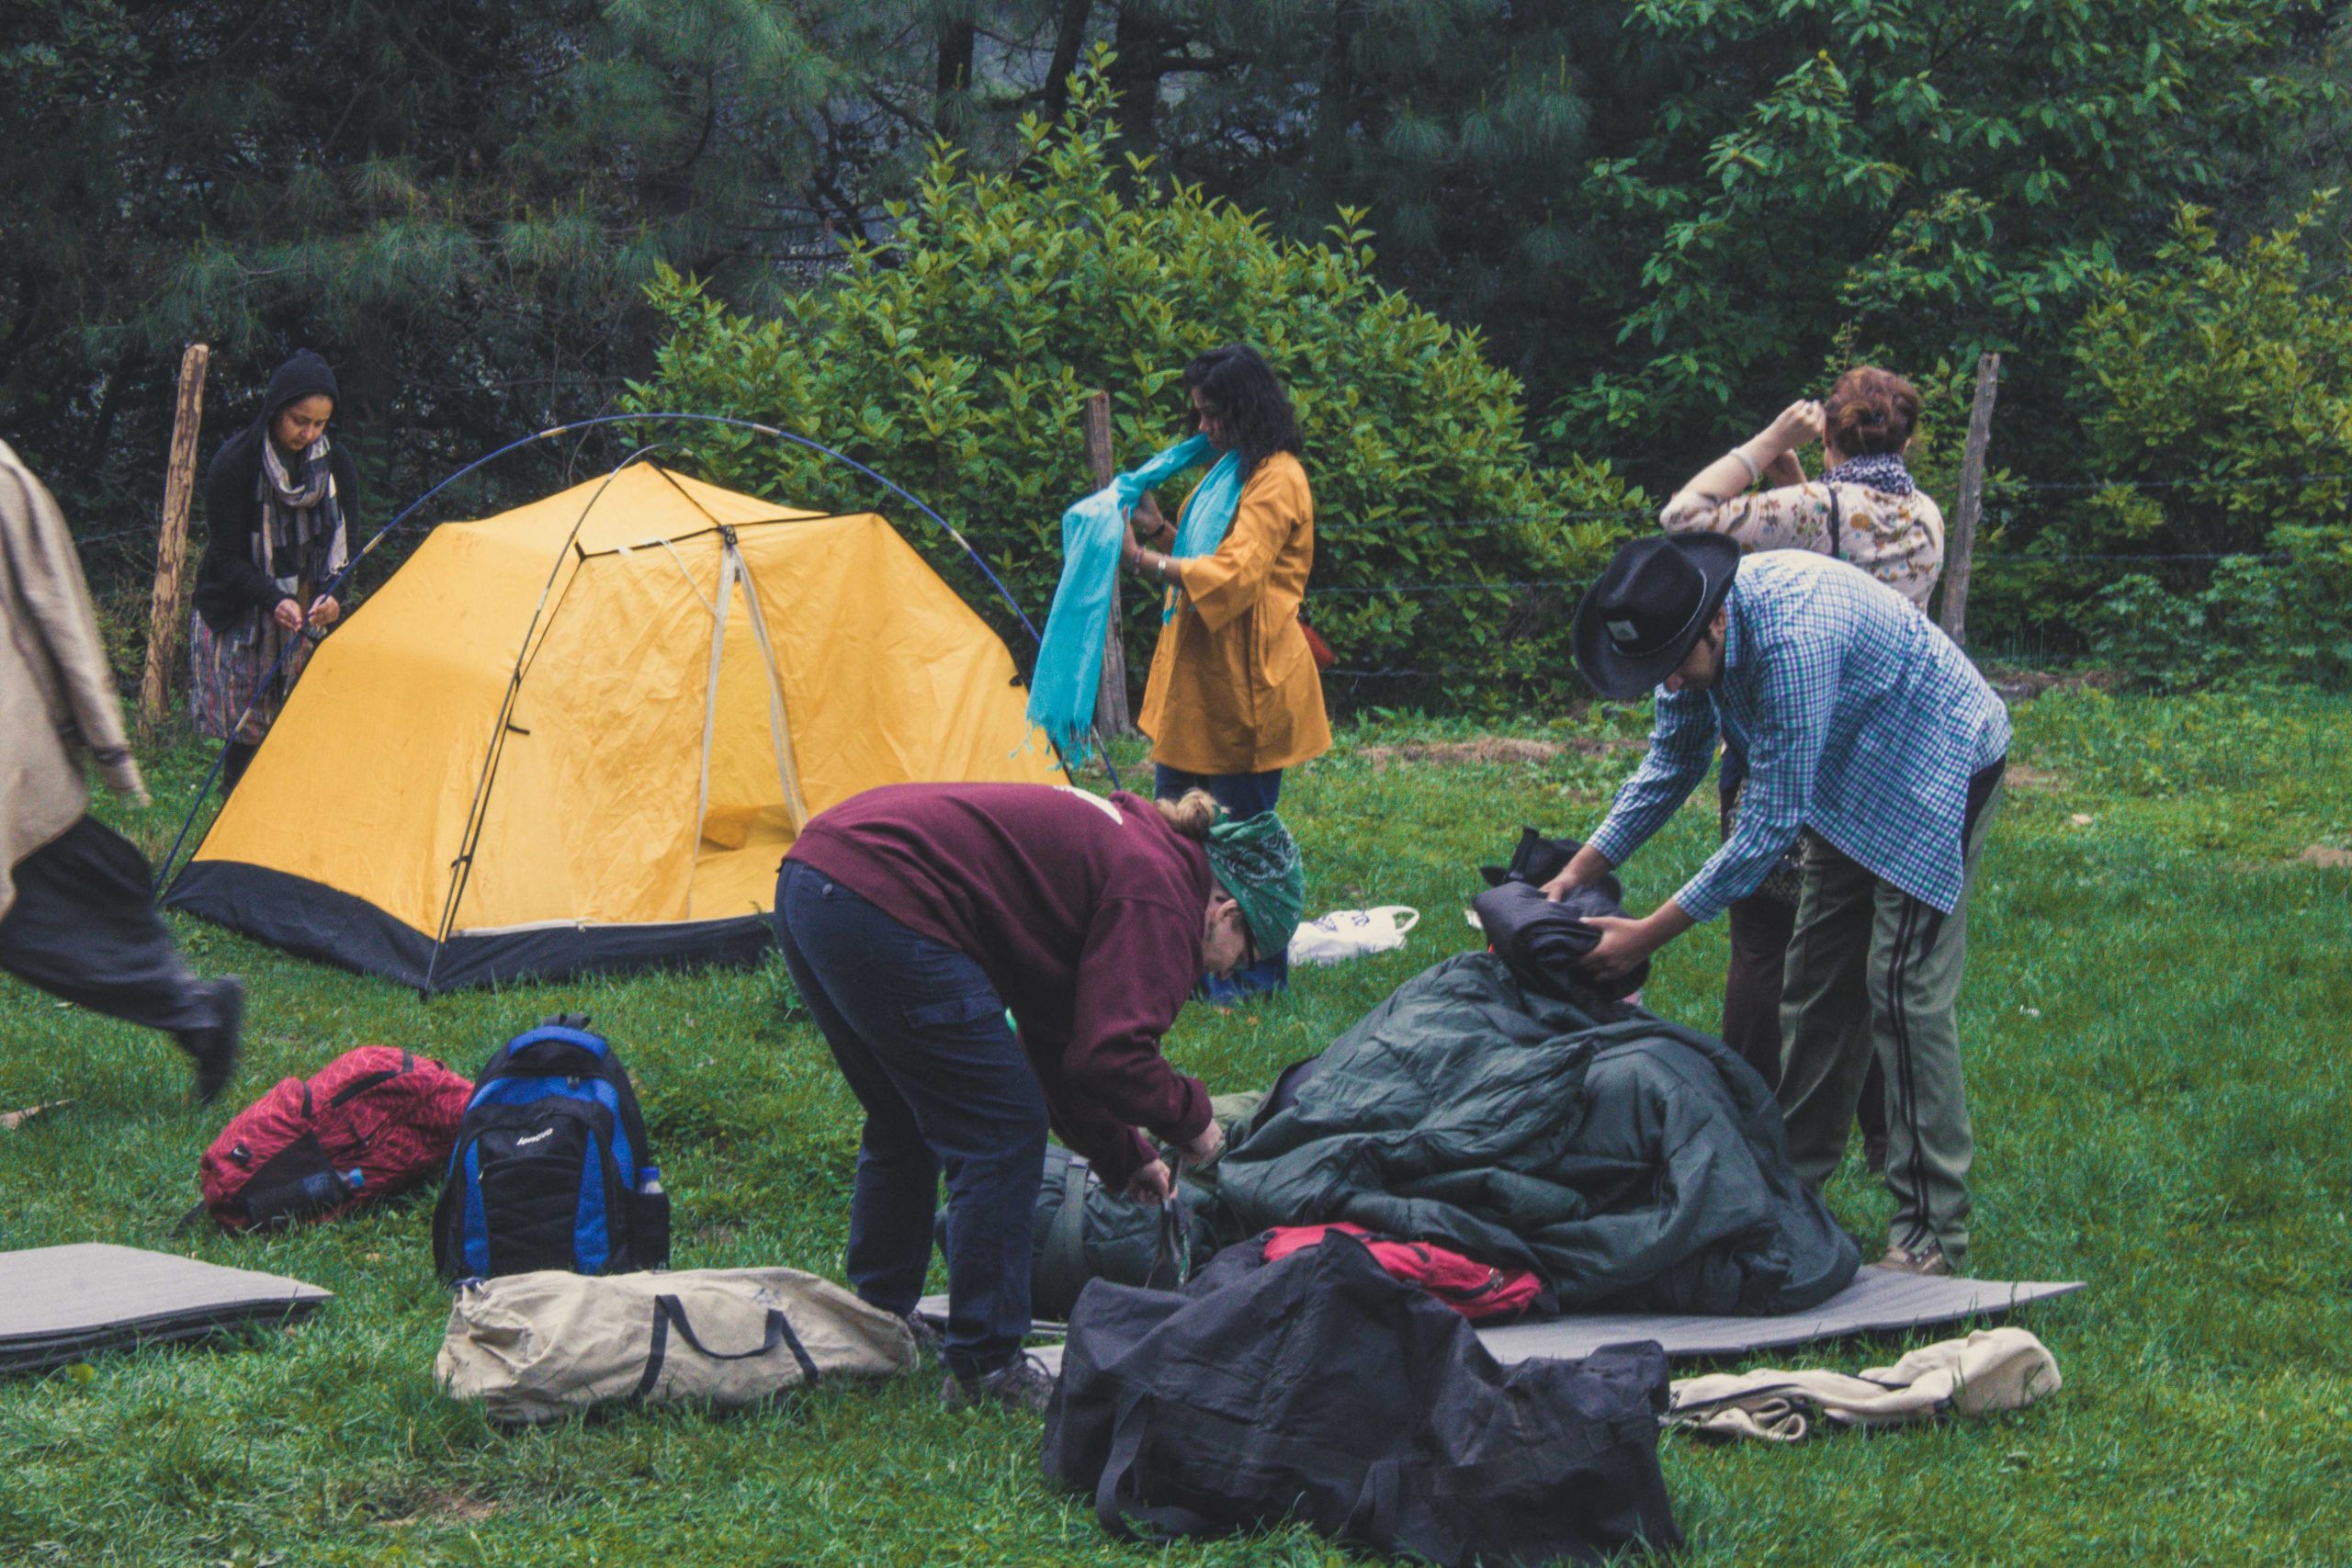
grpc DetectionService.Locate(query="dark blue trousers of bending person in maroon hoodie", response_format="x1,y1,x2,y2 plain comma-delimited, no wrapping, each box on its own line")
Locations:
776,861,1046,1378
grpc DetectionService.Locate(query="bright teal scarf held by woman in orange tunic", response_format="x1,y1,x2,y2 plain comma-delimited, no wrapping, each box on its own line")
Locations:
1028,434,1242,766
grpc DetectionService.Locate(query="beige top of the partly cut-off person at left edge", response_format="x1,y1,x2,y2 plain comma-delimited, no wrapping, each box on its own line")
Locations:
0,442,146,915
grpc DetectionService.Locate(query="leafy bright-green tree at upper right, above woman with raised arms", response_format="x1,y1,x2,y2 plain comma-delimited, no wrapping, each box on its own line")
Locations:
1557,0,2322,479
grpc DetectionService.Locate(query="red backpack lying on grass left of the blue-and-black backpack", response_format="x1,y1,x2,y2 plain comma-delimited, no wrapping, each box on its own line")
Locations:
190,1046,473,1229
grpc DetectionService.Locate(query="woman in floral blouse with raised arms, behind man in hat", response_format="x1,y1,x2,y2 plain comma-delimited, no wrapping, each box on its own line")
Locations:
1658,365,1943,1170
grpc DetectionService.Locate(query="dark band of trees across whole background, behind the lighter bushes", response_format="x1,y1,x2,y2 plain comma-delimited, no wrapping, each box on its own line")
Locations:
14,0,2352,686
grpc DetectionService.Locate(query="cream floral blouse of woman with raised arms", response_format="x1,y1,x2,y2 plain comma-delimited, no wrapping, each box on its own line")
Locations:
1658,479,1943,611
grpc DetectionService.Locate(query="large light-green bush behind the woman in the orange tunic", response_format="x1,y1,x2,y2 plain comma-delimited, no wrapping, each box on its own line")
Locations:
628,59,1642,705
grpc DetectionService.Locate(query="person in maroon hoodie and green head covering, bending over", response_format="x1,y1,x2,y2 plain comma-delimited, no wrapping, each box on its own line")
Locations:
776,783,1303,1411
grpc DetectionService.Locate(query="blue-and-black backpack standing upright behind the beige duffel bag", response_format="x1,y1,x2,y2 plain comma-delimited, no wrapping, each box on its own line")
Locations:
433,1013,671,1279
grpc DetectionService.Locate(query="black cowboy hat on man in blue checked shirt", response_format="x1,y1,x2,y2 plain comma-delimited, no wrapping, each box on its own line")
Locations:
1576,534,1740,703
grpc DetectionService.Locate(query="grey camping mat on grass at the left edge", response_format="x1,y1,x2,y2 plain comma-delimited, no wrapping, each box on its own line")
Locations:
0,1241,334,1373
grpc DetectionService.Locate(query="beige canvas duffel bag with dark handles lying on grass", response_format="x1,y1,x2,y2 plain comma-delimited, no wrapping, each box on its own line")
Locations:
433,1269,915,1422
